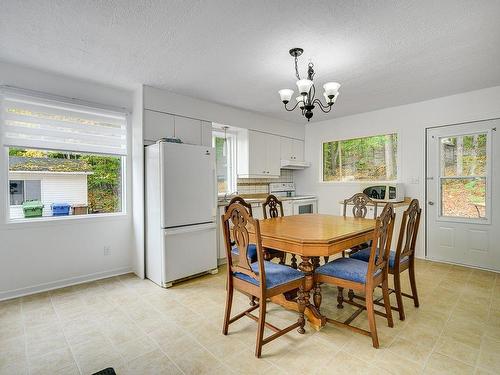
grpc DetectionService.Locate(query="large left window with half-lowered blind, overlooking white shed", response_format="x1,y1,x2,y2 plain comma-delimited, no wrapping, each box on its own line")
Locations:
1,91,127,220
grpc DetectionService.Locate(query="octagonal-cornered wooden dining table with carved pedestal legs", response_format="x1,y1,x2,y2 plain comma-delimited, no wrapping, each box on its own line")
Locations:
249,214,375,330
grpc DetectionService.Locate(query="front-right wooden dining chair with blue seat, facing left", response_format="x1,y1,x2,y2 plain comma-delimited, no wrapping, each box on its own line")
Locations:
314,203,396,348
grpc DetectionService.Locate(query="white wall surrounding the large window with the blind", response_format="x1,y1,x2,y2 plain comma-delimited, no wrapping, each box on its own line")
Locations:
0,63,133,299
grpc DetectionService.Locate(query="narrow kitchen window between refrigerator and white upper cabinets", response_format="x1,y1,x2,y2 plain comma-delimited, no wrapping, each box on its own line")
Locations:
212,130,237,194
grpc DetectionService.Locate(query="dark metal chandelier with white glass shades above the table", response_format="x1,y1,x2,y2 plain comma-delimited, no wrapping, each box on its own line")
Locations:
278,48,340,121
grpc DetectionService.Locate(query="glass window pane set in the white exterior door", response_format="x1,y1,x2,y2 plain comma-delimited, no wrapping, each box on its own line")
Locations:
439,133,488,219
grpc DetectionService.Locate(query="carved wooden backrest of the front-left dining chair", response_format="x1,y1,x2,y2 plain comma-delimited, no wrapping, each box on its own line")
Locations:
221,203,265,288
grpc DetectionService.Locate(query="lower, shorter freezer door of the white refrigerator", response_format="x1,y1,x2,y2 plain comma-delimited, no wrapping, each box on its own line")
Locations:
163,223,217,283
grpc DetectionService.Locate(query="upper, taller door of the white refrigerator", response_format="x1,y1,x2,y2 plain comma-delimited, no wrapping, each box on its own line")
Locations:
160,143,217,228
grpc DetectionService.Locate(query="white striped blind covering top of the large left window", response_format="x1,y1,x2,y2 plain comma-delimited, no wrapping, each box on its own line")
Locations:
1,93,127,155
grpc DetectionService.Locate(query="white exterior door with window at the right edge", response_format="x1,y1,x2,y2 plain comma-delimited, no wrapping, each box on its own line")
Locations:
426,119,500,271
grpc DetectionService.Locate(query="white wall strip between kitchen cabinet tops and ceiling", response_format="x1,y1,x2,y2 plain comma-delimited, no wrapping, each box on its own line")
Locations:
144,86,304,139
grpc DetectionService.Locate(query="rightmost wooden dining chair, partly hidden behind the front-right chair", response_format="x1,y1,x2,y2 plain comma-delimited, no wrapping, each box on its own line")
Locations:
351,199,422,320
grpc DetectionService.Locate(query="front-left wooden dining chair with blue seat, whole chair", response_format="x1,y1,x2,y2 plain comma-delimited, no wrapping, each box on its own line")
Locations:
221,203,305,357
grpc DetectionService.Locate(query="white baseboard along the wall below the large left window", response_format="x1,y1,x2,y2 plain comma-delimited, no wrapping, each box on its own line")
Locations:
0,267,133,301
